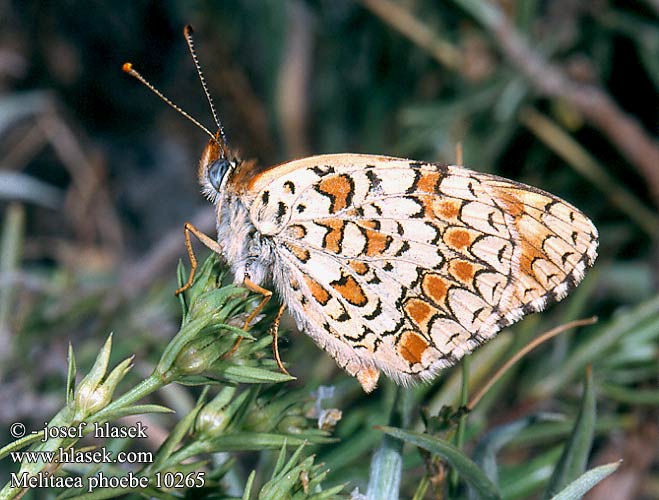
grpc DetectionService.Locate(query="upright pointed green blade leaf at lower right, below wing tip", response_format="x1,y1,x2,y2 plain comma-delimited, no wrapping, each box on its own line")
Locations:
544,368,596,498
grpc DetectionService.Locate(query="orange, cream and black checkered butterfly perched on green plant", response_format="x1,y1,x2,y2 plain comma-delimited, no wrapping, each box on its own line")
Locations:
124,27,597,392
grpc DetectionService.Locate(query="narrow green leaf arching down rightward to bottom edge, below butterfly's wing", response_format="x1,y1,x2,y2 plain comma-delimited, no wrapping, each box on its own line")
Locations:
378,427,500,499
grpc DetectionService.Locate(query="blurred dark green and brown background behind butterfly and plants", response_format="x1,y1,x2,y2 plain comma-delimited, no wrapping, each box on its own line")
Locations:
0,0,659,499
